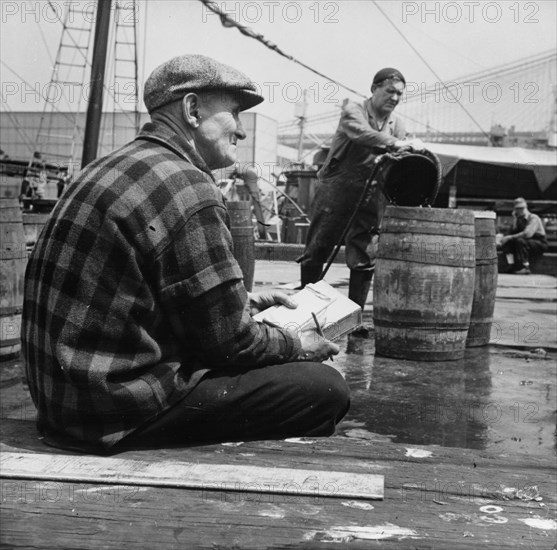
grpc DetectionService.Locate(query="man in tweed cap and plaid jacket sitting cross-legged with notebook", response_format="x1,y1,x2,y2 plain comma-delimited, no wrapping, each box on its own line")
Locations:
22,55,349,452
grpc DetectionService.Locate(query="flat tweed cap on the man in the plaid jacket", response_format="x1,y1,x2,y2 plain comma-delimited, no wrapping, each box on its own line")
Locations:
143,54,264,113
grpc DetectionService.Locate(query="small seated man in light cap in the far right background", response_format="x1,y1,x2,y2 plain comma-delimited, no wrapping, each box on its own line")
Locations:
500,197,547,275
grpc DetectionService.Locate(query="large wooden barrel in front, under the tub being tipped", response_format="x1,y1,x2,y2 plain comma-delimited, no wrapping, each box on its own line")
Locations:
373,206,476,361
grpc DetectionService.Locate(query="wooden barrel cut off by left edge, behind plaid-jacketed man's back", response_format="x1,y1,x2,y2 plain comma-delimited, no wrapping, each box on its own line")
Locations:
0,199,27,360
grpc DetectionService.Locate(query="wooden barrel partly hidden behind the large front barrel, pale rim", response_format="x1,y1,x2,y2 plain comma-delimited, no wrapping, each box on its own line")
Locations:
466,211,498,347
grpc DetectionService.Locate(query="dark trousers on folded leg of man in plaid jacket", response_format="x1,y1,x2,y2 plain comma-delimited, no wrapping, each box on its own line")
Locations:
119,362,350,447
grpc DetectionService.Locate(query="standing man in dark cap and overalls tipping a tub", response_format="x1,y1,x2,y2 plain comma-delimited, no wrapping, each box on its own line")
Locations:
298,68,423,328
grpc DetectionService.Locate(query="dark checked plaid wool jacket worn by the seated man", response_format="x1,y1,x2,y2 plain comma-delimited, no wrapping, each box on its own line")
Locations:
21,122,300,448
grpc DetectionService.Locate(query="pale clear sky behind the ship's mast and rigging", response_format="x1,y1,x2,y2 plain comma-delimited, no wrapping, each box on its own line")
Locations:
0,0,557,126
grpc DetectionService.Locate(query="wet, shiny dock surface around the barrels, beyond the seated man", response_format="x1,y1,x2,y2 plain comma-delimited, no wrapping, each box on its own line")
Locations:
255,262,557,457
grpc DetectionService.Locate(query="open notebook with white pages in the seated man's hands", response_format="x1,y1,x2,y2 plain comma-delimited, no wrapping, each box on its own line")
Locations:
253,281,362,341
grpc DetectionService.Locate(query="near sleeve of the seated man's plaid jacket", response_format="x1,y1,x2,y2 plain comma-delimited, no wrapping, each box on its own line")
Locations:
156,201,299,367
